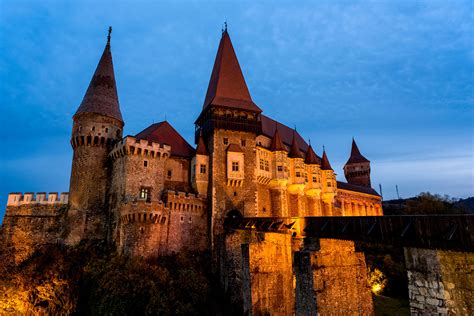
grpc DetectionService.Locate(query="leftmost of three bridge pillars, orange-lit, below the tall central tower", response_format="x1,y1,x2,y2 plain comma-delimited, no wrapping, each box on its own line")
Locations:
220,230,295,315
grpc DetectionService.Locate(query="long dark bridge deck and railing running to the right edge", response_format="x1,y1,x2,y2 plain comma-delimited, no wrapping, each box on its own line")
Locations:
226,215,474,252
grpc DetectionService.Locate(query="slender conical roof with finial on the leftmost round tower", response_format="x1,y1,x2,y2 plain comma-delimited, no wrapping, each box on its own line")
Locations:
74,27,123,122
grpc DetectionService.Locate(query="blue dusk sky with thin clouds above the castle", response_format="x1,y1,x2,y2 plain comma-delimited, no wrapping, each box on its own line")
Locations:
0,0,474,215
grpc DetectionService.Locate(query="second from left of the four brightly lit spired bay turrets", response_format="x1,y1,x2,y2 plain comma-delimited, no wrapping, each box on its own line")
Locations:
288,131,306,216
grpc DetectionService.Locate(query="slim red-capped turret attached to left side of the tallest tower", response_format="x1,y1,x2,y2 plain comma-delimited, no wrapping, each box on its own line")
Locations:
191,134,209,197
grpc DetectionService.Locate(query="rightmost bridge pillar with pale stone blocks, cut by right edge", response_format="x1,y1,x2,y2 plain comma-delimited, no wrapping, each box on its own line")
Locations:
404,248,474,315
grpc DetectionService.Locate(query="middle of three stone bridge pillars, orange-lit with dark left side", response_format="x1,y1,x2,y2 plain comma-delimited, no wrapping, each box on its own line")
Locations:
294,238,373,315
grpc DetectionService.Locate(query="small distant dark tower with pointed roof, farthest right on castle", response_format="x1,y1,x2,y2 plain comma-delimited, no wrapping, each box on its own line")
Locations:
344,138,371,188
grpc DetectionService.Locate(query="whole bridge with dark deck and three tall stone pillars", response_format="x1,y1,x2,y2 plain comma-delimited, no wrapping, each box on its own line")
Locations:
222,215,474,315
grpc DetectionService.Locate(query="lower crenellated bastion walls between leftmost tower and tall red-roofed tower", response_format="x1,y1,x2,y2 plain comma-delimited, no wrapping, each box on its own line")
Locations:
115,191,208,257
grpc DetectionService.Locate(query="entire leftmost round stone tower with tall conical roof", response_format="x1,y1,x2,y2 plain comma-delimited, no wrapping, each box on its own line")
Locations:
69,28,124,241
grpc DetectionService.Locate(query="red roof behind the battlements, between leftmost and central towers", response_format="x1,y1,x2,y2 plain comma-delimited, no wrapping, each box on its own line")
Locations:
135,121,195,158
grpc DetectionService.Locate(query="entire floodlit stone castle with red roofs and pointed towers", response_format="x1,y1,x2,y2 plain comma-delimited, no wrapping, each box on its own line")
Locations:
2,30,382,261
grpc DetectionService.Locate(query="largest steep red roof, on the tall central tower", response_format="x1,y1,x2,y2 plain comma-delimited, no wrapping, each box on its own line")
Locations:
203,30,262,113
